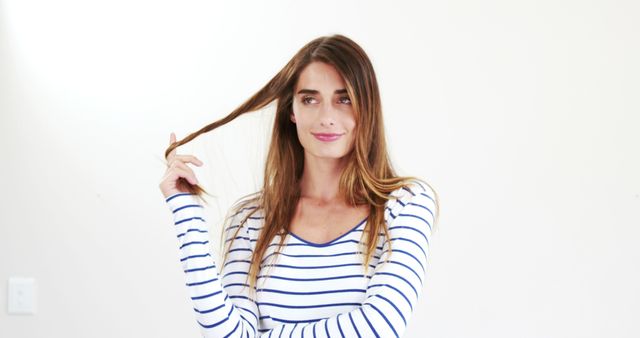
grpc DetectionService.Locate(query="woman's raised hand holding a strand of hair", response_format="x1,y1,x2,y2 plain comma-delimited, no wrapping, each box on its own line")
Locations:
160,133,202,198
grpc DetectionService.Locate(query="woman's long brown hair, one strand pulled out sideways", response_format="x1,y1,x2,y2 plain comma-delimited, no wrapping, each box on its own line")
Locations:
165,34,437,289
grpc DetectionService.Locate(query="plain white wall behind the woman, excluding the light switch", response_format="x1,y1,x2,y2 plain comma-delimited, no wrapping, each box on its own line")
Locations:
0,0,640,338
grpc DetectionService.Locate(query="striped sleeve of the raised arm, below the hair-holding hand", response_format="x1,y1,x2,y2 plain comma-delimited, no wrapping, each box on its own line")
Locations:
166,193,258,337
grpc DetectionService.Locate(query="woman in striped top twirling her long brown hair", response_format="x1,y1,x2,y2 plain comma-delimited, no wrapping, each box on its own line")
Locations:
160,35,438,337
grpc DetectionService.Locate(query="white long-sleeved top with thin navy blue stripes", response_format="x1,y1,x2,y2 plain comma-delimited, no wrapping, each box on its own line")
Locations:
166,181,436,337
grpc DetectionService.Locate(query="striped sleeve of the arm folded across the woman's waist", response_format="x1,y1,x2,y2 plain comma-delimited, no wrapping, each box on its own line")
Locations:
262,183,437,337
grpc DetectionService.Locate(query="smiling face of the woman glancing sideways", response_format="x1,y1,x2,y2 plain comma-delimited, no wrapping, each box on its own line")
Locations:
291,62,356,159
